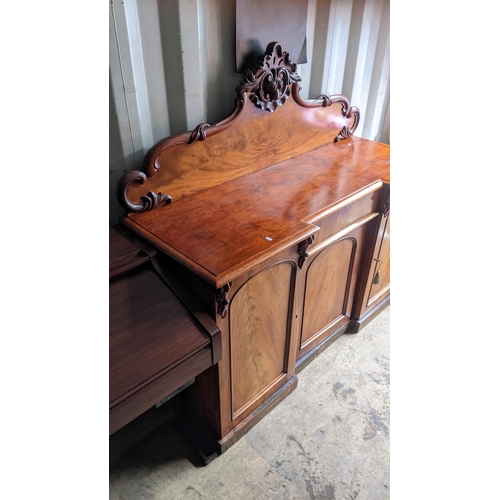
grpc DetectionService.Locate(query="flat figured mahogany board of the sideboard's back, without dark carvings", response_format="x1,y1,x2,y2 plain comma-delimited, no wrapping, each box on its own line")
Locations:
128,90,353,207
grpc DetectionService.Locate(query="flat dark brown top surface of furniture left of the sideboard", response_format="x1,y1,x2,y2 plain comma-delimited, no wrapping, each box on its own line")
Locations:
109,268,211,407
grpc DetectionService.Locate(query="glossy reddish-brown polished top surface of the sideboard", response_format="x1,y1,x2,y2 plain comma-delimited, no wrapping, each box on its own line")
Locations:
122,137,390,286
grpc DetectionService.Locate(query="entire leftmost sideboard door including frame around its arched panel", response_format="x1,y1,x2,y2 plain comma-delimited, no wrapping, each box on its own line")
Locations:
204,248,297,439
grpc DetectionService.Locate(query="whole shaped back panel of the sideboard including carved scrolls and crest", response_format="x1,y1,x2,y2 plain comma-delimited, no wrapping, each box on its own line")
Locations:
117,42,359,212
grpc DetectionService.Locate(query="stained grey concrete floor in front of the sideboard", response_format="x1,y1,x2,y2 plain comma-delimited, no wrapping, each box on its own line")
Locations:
109,307,390,500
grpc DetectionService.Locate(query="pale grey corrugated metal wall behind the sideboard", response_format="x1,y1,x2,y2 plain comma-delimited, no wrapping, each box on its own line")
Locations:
109,0,390,224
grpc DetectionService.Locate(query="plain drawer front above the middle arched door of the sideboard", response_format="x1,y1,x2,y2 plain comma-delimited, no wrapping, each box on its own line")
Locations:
307,183,382,248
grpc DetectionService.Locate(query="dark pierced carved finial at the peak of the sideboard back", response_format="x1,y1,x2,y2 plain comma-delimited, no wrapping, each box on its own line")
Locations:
236,42,301,111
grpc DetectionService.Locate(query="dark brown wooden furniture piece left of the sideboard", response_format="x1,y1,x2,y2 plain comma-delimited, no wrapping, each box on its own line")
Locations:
109,227,221,434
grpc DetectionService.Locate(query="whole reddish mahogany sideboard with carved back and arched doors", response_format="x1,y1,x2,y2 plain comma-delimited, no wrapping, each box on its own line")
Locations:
114,43,390,452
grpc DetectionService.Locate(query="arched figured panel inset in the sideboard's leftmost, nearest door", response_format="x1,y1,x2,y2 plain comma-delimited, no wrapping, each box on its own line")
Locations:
229,261,296,420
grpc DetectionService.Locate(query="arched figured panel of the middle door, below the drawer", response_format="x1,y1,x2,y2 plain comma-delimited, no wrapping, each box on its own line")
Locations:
299,237,357,356
